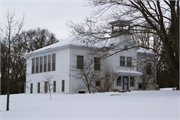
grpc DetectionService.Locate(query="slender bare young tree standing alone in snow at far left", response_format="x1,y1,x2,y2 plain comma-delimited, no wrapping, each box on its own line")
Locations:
1,11,24,111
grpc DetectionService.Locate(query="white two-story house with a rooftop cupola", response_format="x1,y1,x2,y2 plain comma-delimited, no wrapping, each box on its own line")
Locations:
24,21,156,93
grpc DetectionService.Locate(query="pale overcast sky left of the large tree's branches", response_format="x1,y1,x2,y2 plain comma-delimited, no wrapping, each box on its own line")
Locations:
0,0,93,39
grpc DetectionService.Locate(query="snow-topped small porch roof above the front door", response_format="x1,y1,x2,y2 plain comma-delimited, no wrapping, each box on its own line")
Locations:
115,69,143,76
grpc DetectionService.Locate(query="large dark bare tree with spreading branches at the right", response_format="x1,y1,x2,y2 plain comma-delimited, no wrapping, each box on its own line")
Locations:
69,0,179,89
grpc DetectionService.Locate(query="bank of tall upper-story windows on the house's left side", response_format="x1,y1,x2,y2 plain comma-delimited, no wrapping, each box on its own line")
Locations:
32,54,56,74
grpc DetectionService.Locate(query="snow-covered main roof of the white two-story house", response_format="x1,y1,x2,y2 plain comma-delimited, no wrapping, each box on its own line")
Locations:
23,36,153,58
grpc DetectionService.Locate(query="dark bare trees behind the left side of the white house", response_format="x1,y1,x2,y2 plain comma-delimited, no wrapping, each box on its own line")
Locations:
0,28,58,94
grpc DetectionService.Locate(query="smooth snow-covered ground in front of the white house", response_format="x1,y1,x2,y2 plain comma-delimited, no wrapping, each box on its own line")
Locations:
0,90,180,120
